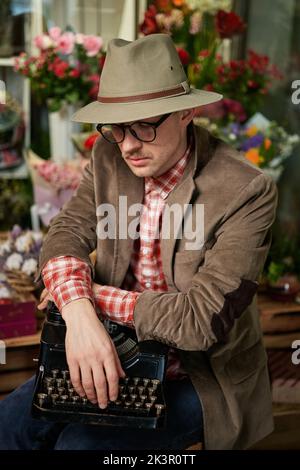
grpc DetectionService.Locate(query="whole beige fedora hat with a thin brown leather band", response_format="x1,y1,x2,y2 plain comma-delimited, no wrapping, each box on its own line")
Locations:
72,34,222,124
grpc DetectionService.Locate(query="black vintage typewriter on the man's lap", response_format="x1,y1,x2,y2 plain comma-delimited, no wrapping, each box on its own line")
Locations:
32,302,168,429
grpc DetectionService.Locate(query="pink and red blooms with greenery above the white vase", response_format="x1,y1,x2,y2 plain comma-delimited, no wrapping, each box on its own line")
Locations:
15,27,105,112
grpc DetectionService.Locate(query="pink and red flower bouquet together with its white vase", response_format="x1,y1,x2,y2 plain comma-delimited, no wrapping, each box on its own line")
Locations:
15,27,105,163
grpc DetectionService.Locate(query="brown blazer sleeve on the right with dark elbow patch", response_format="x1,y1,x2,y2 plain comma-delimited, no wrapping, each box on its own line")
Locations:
134,173,277,351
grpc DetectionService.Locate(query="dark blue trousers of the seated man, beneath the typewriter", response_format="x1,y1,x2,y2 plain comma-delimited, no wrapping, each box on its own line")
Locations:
0,378,203,450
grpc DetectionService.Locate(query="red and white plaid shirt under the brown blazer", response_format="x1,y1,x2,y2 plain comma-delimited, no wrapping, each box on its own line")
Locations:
42,142,191,377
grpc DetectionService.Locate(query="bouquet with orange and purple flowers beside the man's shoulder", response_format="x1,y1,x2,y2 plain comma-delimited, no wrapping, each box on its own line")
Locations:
195,113,300,181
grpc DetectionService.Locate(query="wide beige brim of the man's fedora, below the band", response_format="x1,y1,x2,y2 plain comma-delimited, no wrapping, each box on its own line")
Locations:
72,89,223,124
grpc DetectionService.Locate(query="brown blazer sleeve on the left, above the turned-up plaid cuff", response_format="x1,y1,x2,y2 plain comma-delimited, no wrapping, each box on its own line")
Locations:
35,146,97,282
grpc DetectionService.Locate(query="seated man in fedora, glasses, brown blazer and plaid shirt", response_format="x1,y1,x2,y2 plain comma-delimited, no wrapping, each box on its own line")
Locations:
0,34,276,450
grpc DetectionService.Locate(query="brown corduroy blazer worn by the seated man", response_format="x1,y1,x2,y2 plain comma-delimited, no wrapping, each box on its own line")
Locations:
38,127,277,449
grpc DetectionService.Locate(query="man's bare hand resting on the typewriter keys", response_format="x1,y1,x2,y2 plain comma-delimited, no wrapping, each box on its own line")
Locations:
61,299,125,408
